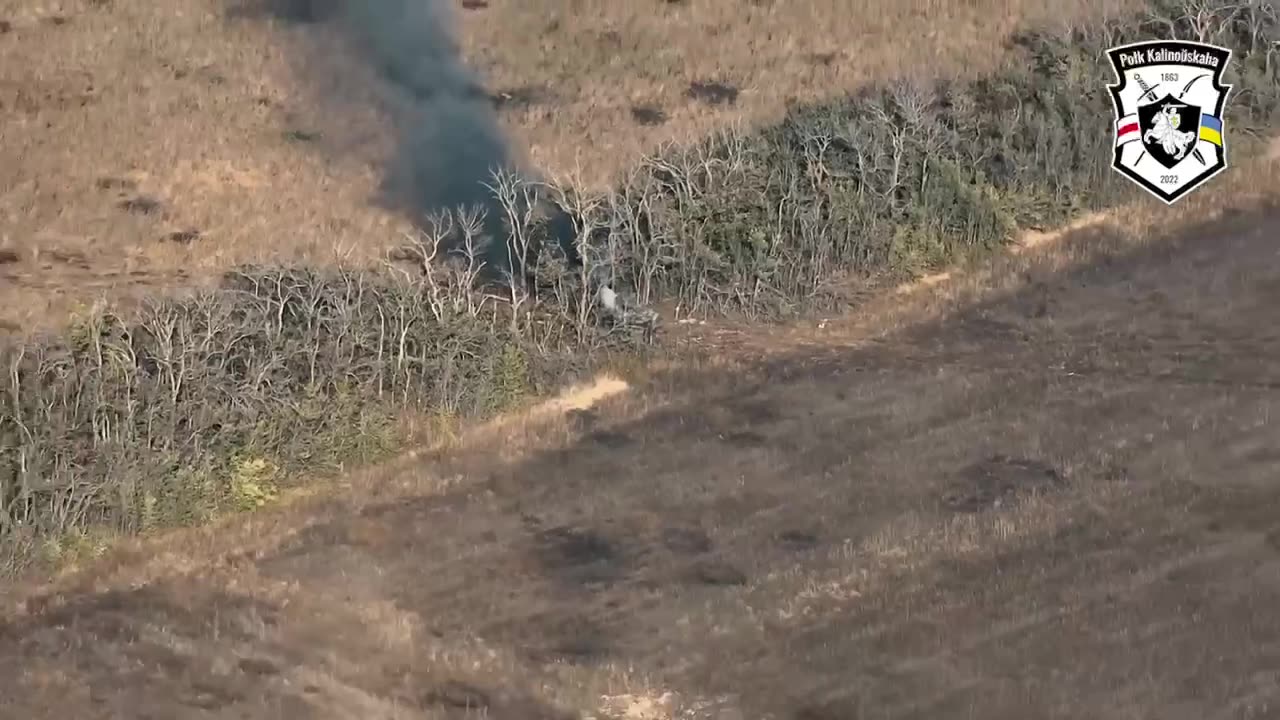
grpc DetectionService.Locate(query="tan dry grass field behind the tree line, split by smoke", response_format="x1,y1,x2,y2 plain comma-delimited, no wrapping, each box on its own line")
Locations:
0,0,1132,331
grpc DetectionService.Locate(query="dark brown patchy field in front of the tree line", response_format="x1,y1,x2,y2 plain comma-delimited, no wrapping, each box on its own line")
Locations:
0,203,1280,720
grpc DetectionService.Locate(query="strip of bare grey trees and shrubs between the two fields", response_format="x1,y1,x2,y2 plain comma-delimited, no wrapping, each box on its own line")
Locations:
0,0,1280,566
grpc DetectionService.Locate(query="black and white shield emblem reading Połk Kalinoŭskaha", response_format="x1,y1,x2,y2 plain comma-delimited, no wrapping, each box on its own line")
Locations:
1107,40,1231,205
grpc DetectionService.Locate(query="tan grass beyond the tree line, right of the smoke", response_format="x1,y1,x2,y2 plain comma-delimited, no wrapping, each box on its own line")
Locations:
461,0,1134,187
